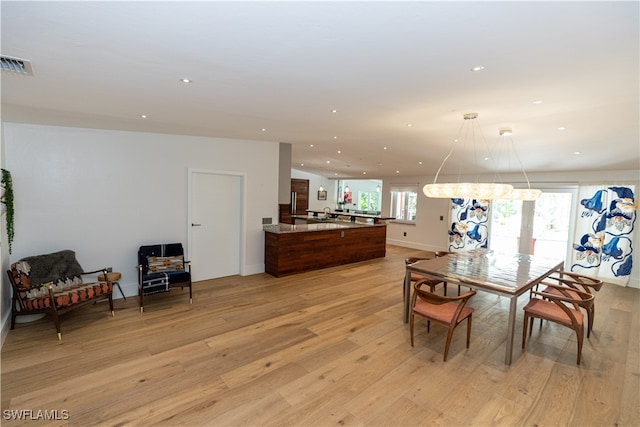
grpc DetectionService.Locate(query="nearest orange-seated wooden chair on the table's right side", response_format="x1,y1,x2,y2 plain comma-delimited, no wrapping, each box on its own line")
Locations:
522,279,594,365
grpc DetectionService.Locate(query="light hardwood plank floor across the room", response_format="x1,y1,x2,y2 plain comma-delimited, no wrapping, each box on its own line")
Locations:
1,246,640,426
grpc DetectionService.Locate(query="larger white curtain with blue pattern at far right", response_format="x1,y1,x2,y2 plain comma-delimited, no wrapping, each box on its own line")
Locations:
570,186,638,285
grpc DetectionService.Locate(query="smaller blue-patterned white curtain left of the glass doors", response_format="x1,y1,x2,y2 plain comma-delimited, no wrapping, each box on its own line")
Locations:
449,199,490,252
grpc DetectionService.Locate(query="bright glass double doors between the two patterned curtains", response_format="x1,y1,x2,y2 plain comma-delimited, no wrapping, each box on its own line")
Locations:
489,189,575,259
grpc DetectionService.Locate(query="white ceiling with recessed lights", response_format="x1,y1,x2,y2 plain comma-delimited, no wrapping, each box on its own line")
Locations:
1,0,640,178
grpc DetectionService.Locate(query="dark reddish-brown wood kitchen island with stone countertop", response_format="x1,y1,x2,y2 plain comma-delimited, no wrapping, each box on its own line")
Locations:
264,220,387,277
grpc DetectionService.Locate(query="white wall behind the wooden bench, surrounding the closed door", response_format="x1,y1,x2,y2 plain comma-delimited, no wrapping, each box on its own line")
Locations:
2,123,280,322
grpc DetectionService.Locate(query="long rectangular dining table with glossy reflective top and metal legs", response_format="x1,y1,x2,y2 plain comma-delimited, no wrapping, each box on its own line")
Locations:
403,248,564,365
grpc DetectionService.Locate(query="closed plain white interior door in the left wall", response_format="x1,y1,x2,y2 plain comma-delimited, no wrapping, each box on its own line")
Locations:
189,171,244,281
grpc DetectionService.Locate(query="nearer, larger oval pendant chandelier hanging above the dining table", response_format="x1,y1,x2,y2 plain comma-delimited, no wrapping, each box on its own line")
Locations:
422,113,513,200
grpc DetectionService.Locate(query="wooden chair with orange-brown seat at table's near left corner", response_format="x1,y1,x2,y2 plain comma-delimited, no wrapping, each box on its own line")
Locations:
409,279,476,362
